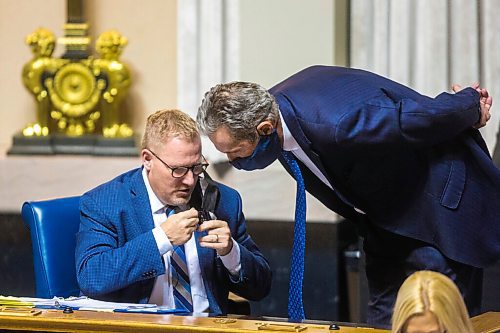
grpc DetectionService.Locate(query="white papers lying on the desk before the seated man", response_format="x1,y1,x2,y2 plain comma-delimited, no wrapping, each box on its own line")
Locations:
22,296,156,311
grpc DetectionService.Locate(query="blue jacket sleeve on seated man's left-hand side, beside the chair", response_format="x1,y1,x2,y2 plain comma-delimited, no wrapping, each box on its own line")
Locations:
75,195,165,297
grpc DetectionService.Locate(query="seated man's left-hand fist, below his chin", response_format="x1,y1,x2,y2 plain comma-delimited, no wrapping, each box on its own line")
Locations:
161,208,198,246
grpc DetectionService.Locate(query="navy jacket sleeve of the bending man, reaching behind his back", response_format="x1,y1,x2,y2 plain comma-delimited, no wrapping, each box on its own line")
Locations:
334,88,480,149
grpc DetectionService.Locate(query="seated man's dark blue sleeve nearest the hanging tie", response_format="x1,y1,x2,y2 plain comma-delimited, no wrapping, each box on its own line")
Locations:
224,191,272,301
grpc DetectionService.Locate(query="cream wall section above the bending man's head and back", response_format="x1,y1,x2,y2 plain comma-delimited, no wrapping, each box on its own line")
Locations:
240,0,334,87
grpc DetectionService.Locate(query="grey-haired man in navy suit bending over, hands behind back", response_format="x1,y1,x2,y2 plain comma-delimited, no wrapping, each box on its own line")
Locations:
197,66,500,325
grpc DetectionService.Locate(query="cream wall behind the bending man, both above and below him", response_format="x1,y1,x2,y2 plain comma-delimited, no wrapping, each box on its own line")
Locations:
219,0,344,222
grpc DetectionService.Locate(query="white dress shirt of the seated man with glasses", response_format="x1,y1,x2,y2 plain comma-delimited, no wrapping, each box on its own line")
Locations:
142,168,241,313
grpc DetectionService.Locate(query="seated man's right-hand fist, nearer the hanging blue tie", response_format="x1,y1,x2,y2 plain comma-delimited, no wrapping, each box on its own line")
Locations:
198,220,233,256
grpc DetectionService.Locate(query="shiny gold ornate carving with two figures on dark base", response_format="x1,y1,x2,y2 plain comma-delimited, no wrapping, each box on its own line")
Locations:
22,24,133,138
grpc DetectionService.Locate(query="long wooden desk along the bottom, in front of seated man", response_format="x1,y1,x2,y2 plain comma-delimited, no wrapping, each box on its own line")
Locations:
0,310,388,333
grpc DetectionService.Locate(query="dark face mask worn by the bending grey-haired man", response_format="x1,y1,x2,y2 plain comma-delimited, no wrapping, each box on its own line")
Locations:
231,129,282,171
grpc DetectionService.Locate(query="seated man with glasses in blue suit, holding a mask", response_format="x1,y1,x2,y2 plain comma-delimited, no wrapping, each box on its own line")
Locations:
76,110,272,314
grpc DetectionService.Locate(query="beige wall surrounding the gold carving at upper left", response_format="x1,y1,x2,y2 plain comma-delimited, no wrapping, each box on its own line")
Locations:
0,0,177,152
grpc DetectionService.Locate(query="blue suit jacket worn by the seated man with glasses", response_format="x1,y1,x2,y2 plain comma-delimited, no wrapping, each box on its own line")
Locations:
76,168,272,314
